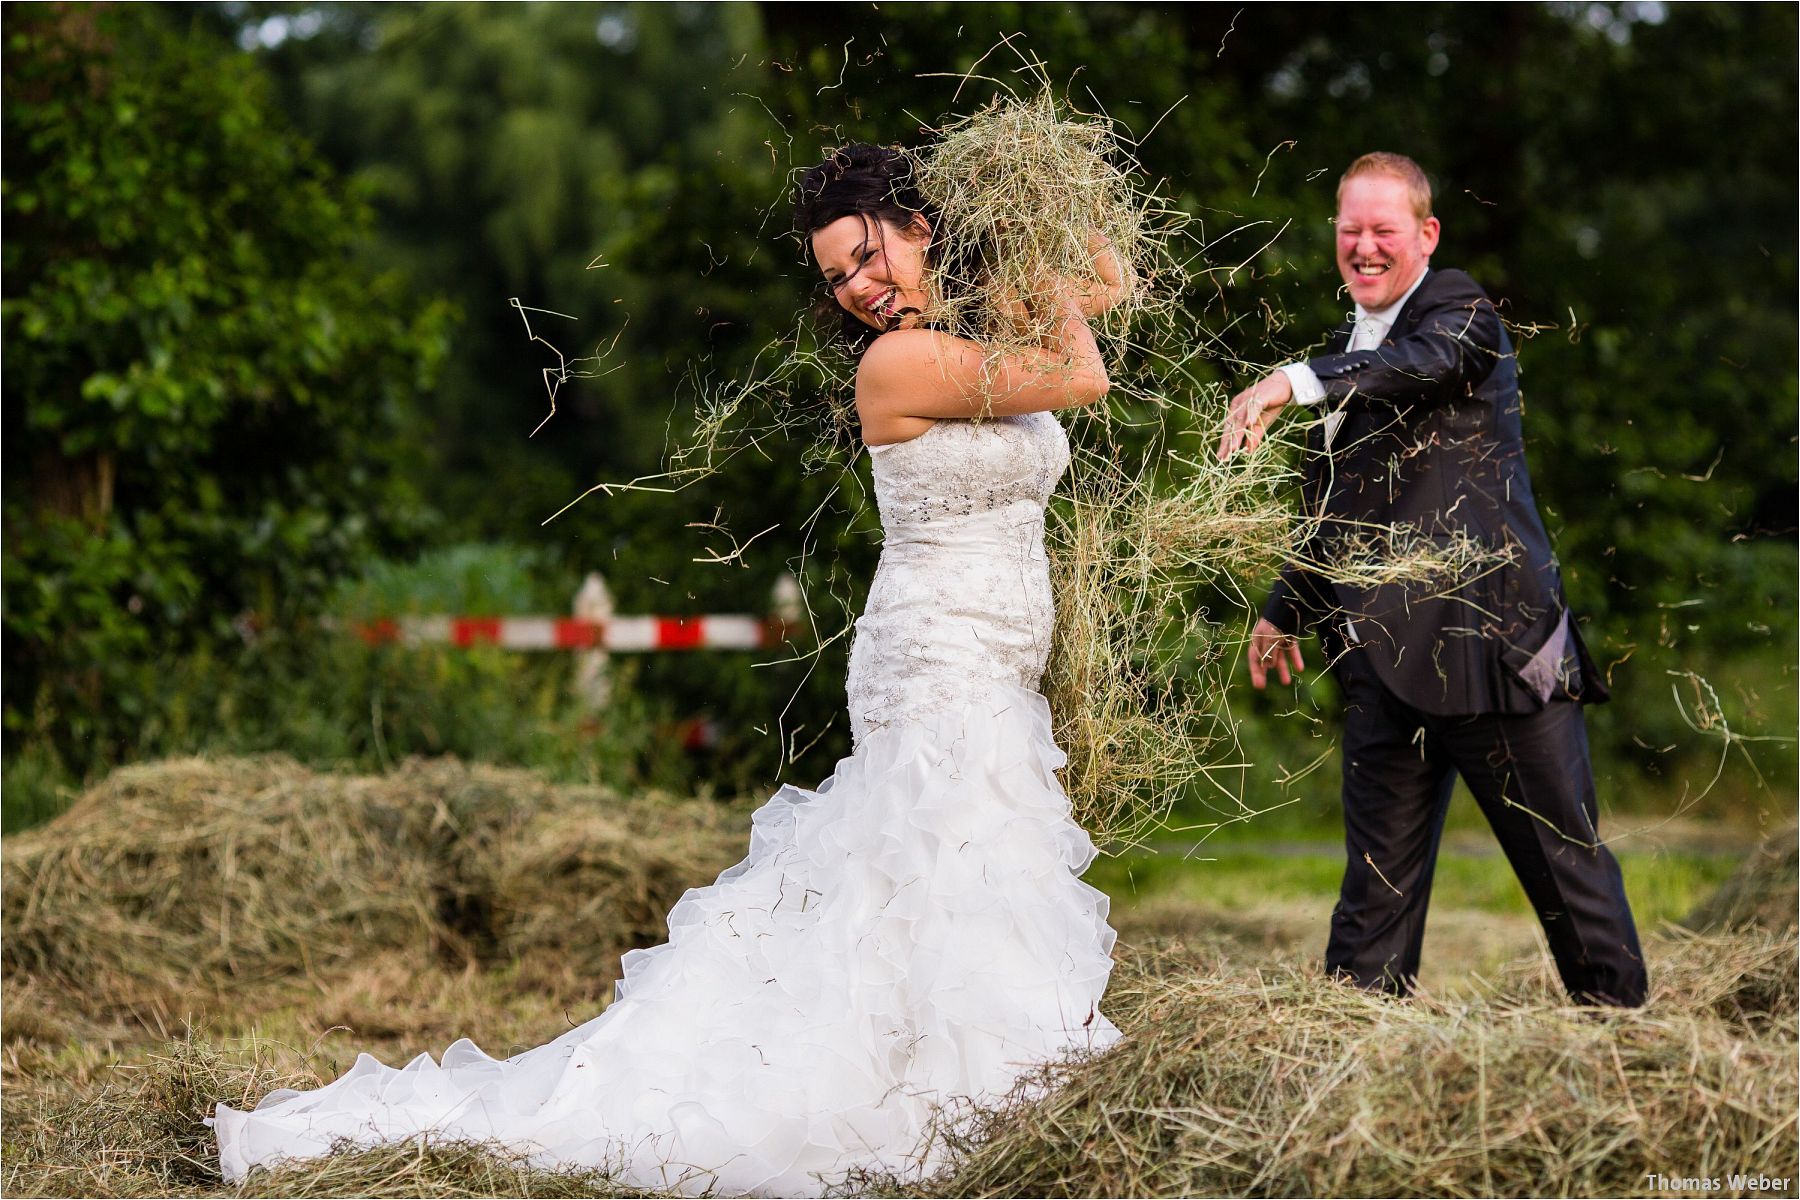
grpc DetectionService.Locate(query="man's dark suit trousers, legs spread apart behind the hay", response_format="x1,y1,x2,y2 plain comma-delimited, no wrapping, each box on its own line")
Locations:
1325,649,1649,1006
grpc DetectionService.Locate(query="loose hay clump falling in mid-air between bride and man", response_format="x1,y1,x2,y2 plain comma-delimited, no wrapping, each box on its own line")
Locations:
1044,433,1294,846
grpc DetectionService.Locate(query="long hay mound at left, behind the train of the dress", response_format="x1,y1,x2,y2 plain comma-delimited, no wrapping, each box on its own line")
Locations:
0,757,743,1038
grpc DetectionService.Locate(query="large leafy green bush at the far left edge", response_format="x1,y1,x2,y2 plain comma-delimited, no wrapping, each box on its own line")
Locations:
0,5,446,772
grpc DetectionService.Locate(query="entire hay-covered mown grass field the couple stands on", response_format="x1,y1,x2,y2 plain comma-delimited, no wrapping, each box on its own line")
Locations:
0,759,1796,1196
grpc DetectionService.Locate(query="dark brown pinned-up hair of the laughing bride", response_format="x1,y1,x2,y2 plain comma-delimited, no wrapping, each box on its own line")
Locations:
794,142,940,351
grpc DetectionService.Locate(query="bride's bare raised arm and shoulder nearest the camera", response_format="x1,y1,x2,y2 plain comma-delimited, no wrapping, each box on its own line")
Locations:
857,293,1111,443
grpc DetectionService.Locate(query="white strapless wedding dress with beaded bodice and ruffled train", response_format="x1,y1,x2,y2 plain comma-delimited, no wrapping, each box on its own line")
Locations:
214,414,1118,1196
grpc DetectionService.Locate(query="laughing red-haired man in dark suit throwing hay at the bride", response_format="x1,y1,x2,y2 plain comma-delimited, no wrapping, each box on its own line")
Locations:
1219,153,1647,1006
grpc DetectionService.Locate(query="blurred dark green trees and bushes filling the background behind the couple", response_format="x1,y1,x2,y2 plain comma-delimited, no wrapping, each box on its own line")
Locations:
4,4,1796,820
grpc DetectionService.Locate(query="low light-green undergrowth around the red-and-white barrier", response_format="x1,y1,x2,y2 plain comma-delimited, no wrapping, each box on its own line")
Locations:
0,545,709,829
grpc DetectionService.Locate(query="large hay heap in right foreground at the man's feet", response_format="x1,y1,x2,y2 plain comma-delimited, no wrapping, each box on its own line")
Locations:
914,934,1796,1196
